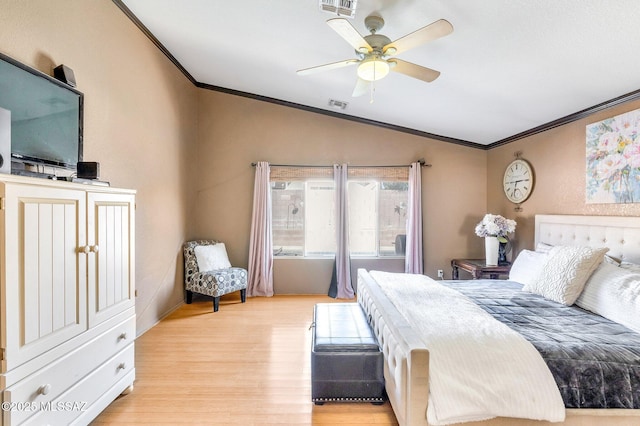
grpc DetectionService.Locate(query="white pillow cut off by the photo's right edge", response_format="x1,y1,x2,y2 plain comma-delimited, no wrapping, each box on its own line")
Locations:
576,262,640,333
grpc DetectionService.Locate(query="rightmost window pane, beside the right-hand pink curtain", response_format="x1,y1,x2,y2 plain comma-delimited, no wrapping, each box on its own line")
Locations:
378,182,409,256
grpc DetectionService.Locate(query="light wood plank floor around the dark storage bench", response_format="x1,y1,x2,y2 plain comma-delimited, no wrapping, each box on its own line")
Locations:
92,293,398,426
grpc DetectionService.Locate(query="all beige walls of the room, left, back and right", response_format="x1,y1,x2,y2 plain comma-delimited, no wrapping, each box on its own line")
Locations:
7,0,640,316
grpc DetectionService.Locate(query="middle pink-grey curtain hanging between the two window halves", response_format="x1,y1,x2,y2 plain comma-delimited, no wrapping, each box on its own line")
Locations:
333,164,355,299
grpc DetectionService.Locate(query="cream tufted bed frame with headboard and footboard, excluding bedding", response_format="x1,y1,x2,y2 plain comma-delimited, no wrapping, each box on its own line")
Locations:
357,215,640,426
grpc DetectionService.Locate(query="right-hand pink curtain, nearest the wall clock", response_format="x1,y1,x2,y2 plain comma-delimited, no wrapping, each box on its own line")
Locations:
404,162,423,274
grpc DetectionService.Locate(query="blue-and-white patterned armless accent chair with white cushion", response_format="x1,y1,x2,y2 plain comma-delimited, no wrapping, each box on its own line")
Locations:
184,240,248,312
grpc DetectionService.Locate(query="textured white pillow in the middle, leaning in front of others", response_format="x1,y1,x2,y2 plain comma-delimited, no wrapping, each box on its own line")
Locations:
523,246,609,306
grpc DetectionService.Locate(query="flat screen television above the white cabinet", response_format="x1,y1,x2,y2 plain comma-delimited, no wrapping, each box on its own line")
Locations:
0,53,84,172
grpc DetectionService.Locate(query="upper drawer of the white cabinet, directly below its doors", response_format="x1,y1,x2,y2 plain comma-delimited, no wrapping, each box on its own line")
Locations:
3,317,136,425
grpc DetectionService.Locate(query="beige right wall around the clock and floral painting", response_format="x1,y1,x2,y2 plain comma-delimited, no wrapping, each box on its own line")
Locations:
487,101,640,252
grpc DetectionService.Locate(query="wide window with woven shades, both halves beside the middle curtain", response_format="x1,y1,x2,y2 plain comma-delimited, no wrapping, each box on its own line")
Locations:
271,167,409,256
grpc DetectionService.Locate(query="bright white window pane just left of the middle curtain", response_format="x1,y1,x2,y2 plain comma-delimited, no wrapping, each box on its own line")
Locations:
304,181,336,256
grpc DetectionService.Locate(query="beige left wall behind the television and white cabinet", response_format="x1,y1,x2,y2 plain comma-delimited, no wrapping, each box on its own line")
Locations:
0,0,197,332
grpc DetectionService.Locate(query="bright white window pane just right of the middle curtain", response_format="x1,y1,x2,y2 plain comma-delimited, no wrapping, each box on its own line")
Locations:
348,180,378,256
